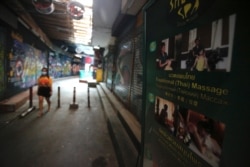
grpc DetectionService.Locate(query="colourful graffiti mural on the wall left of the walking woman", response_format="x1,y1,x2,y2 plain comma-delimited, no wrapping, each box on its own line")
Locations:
8,39,47,88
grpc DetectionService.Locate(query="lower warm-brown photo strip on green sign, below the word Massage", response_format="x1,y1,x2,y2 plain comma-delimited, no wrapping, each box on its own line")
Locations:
154,96,225,166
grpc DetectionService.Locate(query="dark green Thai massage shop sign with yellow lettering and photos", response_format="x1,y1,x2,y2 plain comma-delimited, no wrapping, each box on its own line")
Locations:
143,0,247,167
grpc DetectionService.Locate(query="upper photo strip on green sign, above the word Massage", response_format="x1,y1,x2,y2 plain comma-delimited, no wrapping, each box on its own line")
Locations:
156,14,236,72
